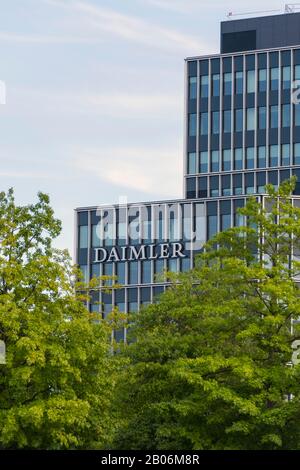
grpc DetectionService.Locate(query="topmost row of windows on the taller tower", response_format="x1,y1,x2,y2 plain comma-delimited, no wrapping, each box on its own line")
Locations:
189,65,300,100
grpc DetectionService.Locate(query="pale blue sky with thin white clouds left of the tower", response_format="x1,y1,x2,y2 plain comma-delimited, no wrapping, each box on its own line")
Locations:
0,0,284,254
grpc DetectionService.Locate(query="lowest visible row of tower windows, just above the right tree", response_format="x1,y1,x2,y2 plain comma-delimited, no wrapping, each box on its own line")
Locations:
186,170,300,199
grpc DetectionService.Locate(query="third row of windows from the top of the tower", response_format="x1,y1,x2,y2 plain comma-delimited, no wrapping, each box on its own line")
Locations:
187,143,300,175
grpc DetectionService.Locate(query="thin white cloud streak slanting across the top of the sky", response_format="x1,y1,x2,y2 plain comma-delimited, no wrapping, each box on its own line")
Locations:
47,0,212,54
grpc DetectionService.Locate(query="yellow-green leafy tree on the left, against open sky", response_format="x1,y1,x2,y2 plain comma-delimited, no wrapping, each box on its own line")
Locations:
0,190,114,449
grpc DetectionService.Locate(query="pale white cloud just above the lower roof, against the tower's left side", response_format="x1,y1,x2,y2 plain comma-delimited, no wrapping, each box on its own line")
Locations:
72,145,182,198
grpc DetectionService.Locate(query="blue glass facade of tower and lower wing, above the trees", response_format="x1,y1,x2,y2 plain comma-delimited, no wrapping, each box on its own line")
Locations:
75,19,300,341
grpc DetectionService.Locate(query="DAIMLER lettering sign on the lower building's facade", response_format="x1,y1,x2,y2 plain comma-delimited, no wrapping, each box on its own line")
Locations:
94,242,187,263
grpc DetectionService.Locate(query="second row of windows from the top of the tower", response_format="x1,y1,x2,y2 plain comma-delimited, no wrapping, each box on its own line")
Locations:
188,104,300,137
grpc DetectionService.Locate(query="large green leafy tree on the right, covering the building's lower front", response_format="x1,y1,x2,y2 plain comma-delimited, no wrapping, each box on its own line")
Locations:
115,180,300,450
